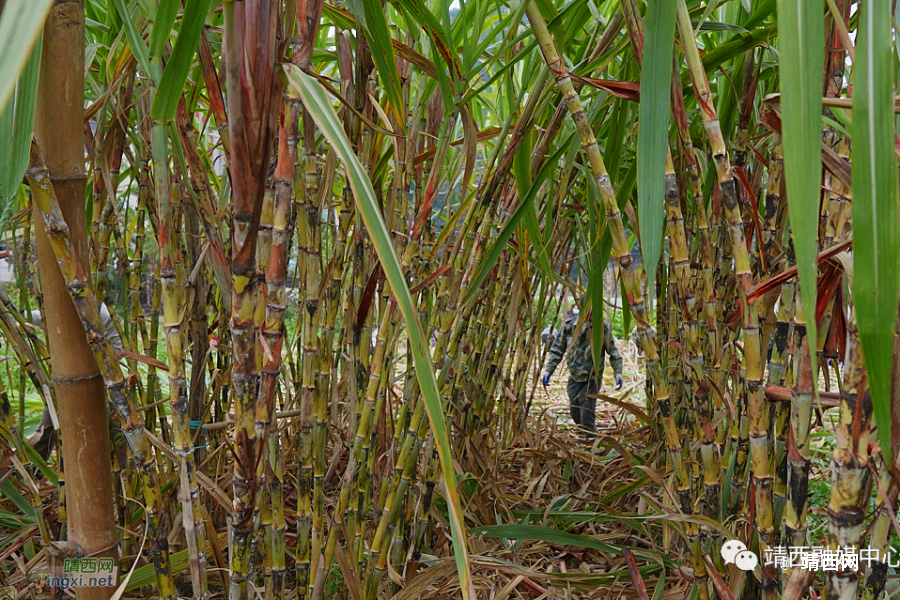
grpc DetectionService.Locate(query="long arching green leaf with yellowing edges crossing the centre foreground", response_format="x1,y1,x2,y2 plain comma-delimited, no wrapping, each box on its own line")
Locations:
283,64,475,600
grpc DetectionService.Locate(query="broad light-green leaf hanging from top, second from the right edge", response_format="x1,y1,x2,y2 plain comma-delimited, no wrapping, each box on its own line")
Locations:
778,0,824,381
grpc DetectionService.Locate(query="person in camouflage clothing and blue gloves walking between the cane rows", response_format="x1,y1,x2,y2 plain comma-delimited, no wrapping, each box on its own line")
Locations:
542,313,624,438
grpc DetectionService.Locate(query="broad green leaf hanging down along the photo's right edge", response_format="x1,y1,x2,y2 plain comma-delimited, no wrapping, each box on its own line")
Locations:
852,0,900,465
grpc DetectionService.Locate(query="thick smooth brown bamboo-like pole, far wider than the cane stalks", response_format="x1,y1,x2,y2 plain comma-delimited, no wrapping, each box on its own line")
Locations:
31,0,125,600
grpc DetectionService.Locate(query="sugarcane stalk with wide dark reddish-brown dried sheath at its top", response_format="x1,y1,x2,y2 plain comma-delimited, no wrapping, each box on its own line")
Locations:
223,0,281,600
